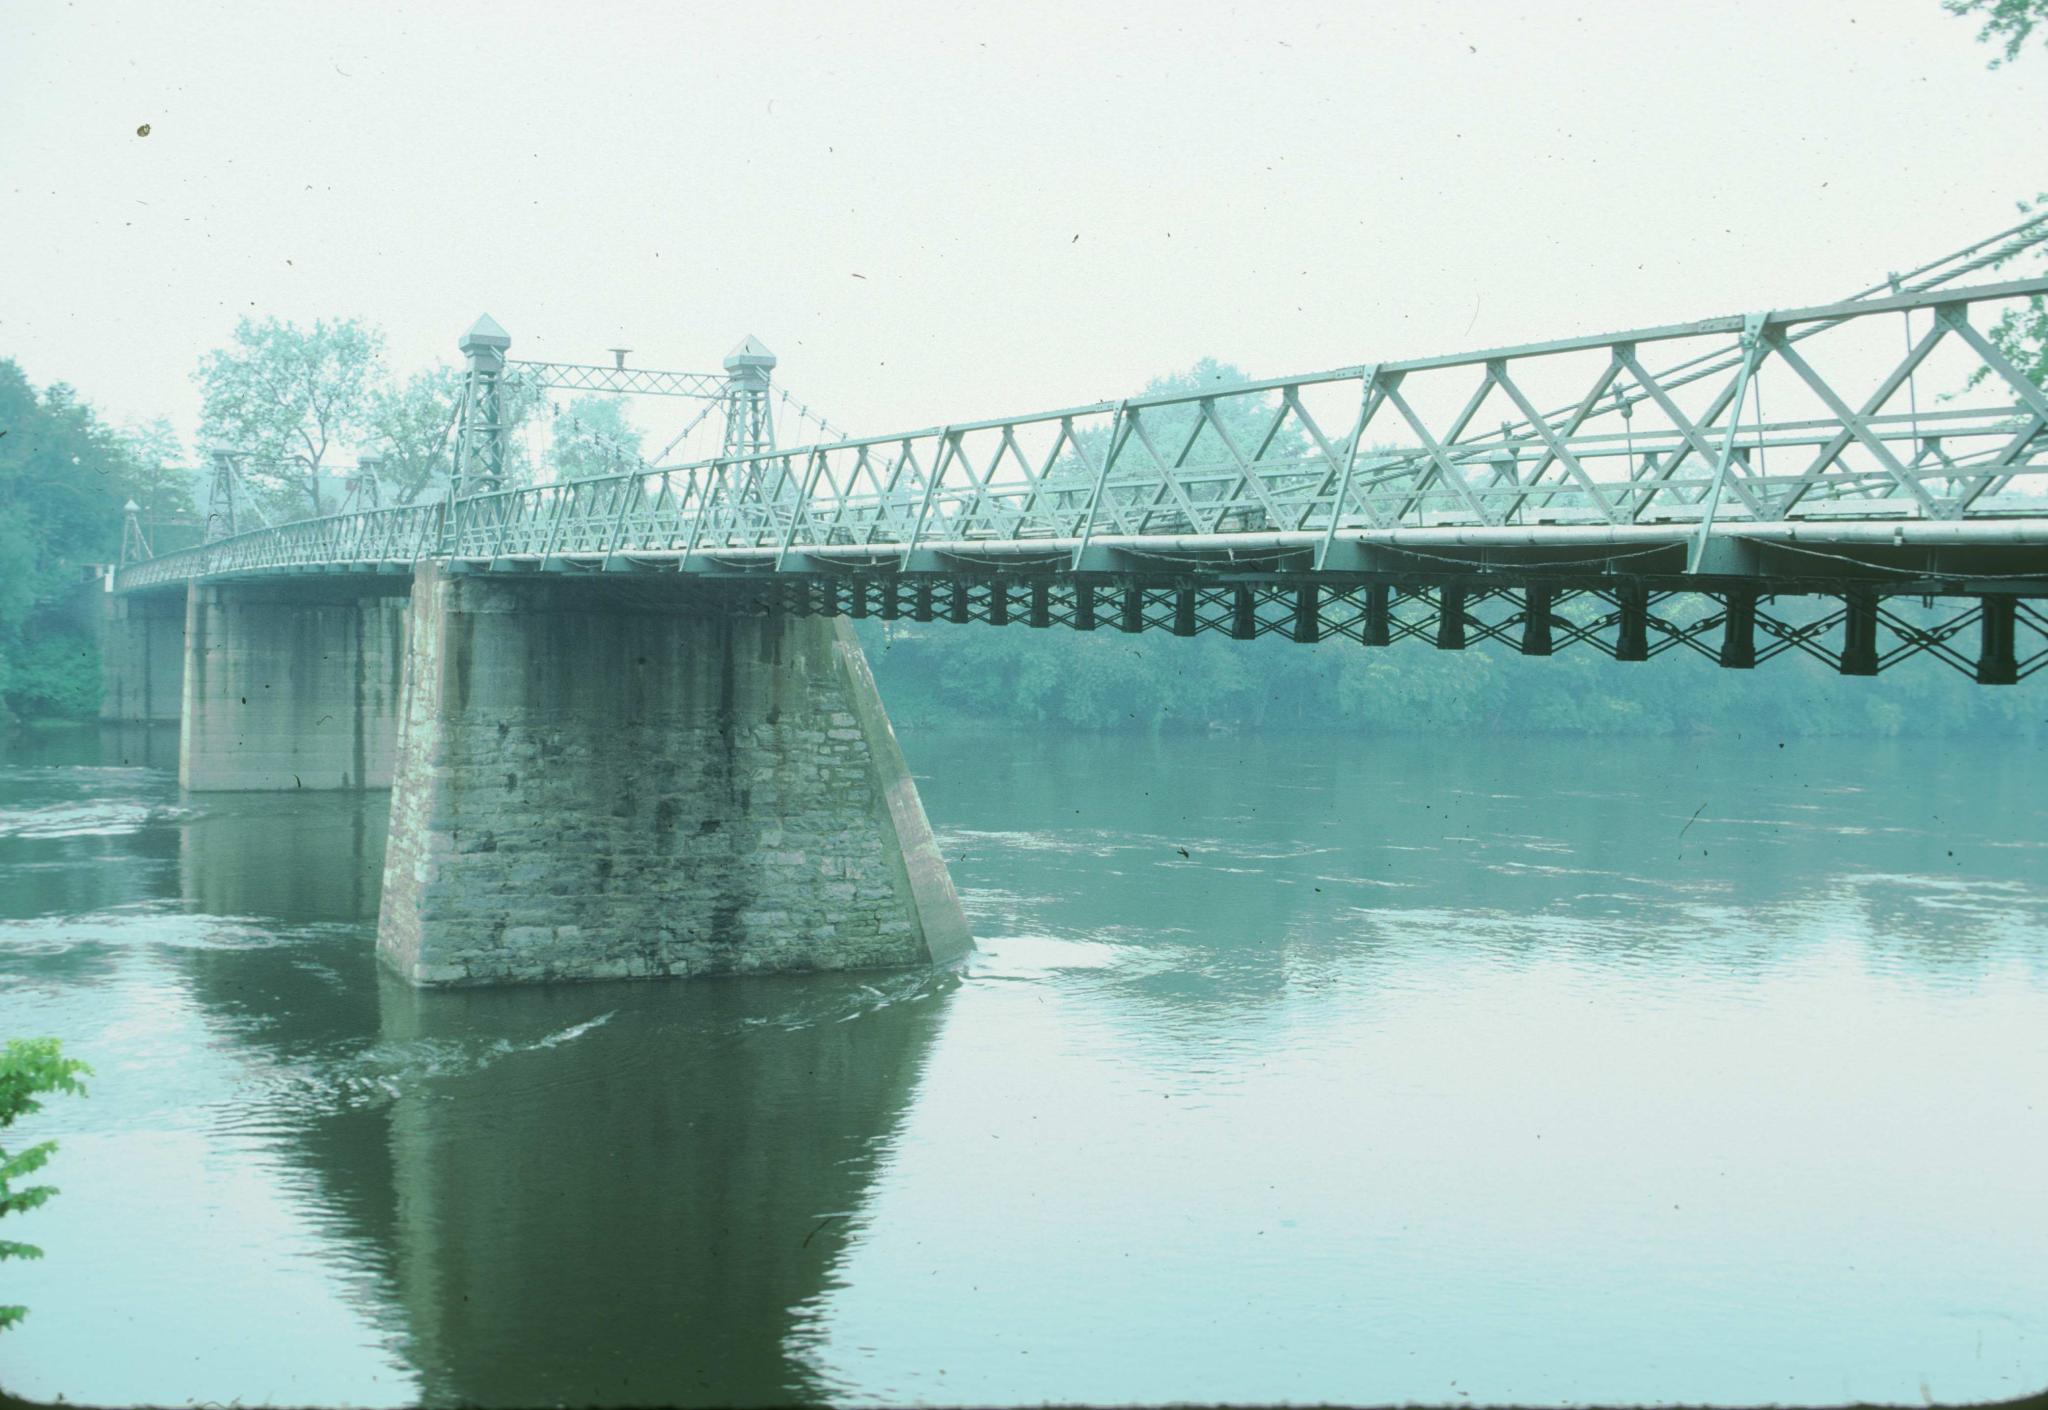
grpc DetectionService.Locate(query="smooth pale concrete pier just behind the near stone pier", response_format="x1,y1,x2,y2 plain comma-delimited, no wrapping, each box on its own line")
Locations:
178,576,410,791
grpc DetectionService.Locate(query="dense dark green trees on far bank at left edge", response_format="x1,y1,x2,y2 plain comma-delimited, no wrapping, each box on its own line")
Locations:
0,361,193,717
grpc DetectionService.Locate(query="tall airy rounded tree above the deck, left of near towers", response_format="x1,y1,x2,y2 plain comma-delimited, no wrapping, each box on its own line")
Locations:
195,318,383,514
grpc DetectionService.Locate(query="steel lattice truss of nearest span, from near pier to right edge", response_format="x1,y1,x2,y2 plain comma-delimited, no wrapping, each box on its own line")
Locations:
432,279,2048,562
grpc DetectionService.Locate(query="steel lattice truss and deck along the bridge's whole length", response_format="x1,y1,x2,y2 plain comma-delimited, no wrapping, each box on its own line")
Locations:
119,279,2048,678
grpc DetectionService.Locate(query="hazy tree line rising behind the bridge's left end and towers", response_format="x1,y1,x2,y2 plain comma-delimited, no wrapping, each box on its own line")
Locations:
0,318,641,721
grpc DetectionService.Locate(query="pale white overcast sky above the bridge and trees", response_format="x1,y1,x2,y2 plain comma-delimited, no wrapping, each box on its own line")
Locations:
0,0,2048,457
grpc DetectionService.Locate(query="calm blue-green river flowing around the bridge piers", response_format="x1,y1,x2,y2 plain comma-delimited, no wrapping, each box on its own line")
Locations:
0,730,2048,1404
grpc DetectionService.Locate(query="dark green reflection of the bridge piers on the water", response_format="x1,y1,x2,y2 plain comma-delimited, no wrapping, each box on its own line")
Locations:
165,793,952,1404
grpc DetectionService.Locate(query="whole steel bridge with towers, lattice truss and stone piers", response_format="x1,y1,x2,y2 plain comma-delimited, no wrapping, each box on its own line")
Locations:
104,219,2048,984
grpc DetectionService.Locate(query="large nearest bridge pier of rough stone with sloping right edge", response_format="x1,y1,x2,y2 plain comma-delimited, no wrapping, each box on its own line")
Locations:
377,566,973,984
